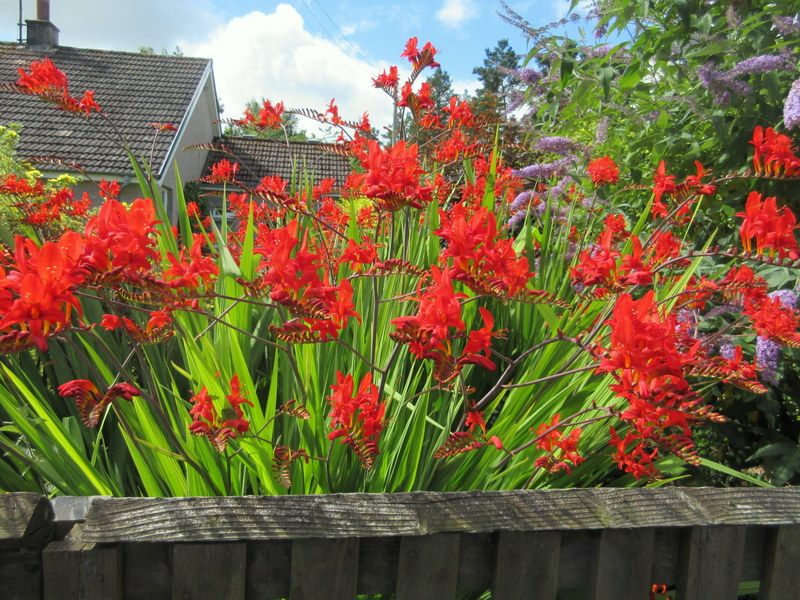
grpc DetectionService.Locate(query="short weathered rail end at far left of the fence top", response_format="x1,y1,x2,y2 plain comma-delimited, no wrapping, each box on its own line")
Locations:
0,492,53,548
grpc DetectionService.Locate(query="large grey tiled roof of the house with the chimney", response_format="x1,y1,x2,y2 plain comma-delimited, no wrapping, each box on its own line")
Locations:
0,42,210,174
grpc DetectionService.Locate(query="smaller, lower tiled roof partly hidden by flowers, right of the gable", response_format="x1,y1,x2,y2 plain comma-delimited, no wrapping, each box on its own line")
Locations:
204,136,352,188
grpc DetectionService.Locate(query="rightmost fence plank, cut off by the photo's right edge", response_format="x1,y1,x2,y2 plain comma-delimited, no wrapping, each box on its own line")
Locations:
759,525,800,600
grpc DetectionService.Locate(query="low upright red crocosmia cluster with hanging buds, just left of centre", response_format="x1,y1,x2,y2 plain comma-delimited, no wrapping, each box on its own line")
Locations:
328,371,386,469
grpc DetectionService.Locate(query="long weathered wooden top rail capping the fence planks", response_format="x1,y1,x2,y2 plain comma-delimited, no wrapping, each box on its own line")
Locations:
76,488,800,543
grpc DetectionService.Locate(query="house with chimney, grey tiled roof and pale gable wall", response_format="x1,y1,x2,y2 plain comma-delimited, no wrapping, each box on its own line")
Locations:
0,1,220,222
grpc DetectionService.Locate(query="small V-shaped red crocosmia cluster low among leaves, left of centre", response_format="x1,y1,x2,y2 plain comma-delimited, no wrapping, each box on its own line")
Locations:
189,375,253,452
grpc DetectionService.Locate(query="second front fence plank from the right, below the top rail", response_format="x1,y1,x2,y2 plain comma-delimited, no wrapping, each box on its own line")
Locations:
677,525,746,600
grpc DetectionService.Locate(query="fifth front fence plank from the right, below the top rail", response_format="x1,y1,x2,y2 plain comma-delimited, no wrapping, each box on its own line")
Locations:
397,533,460,600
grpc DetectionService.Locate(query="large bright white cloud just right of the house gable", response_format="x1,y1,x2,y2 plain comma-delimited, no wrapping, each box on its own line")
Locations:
184,4,391,138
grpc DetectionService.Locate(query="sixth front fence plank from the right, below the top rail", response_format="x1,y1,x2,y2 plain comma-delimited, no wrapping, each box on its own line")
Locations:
289,538,358,600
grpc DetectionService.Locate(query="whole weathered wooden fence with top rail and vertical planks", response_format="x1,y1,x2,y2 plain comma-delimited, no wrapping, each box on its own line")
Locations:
0,487,800,600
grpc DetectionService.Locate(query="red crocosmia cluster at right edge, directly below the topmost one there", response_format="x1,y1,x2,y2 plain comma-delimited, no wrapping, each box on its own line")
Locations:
736,192,800,260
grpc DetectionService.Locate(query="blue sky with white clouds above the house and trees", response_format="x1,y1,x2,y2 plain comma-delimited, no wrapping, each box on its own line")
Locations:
0,0,569,137
